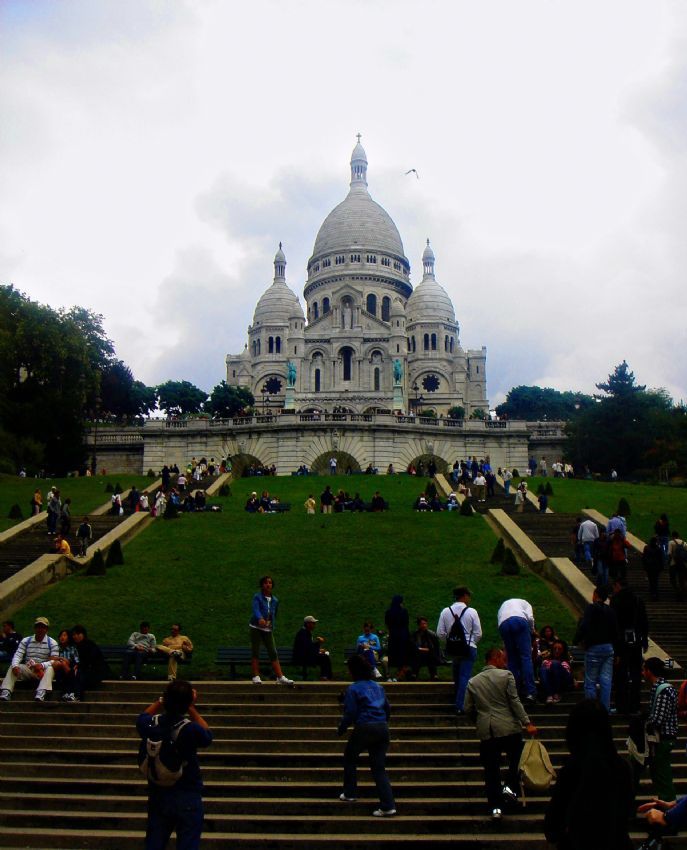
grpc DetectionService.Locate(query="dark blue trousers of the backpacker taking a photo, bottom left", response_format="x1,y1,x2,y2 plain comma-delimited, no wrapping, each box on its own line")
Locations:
145,788,203,850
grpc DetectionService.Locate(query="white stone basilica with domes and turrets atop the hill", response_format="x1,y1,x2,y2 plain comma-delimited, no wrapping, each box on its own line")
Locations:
226,139,489,417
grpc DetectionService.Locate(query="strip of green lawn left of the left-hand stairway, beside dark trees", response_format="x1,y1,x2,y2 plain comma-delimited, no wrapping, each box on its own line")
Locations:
0,475,152,531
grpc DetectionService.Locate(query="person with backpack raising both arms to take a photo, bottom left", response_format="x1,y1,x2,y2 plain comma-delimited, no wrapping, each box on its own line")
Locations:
136,679,212,850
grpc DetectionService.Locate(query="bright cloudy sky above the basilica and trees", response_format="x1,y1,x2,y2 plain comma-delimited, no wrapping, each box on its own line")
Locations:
0,0,687,403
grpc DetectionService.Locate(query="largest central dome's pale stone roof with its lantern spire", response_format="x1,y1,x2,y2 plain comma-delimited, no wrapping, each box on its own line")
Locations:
311,142,407,262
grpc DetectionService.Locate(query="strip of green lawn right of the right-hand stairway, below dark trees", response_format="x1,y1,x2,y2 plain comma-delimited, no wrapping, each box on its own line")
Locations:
527,477,687,541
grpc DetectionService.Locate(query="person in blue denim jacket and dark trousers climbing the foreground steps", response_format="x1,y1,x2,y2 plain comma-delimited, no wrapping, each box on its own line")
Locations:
338,655,396,818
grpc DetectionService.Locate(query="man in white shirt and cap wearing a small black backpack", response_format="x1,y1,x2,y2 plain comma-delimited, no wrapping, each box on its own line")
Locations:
437,586,482,715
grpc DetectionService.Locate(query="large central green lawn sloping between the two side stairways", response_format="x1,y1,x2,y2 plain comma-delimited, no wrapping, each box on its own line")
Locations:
10,476,574,676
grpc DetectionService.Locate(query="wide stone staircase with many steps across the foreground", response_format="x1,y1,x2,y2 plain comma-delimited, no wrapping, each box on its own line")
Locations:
0,682,687,850
